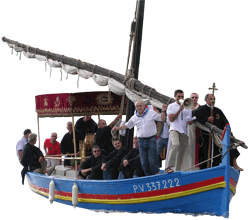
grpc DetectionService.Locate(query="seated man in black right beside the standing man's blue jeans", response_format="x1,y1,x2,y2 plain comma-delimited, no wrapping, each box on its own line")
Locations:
118,137,144,179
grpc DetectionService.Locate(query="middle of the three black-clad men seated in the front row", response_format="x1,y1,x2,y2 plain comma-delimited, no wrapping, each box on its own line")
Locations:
101,139,128,180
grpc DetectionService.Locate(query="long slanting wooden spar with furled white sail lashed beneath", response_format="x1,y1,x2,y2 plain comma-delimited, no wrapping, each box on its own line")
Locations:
2,37,175,104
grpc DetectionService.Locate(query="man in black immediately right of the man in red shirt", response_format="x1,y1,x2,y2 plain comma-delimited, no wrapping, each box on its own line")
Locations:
60,122,84,166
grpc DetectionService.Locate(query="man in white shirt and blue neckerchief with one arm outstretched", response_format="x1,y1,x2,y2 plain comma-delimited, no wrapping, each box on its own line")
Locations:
113,101,162,176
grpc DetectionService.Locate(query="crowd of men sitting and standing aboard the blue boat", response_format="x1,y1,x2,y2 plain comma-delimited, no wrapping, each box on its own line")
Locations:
16,90,243,180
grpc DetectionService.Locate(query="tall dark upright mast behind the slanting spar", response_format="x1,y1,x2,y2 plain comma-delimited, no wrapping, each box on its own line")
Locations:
124,0,145,149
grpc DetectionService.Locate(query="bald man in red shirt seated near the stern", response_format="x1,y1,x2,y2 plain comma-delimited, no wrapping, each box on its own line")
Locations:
44,132,61,167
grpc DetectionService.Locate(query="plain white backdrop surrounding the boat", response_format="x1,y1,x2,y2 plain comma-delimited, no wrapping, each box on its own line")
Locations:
0,0,250,220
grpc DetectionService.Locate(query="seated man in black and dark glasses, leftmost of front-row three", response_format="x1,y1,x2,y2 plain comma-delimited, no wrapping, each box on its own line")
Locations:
79,145,104,180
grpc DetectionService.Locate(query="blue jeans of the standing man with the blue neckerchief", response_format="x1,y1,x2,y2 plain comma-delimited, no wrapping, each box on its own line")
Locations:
138,136,160,176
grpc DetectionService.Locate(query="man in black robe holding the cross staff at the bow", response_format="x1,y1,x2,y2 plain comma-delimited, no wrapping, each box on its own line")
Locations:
194,94,242,170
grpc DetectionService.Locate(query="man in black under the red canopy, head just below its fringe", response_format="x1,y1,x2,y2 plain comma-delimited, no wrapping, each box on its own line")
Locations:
75,115,97,140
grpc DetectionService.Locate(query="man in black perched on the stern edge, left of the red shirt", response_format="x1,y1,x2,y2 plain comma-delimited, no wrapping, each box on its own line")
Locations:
21,133,54,184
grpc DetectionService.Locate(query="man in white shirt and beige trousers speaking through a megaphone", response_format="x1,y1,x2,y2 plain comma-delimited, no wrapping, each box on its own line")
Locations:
163,90,192,173
